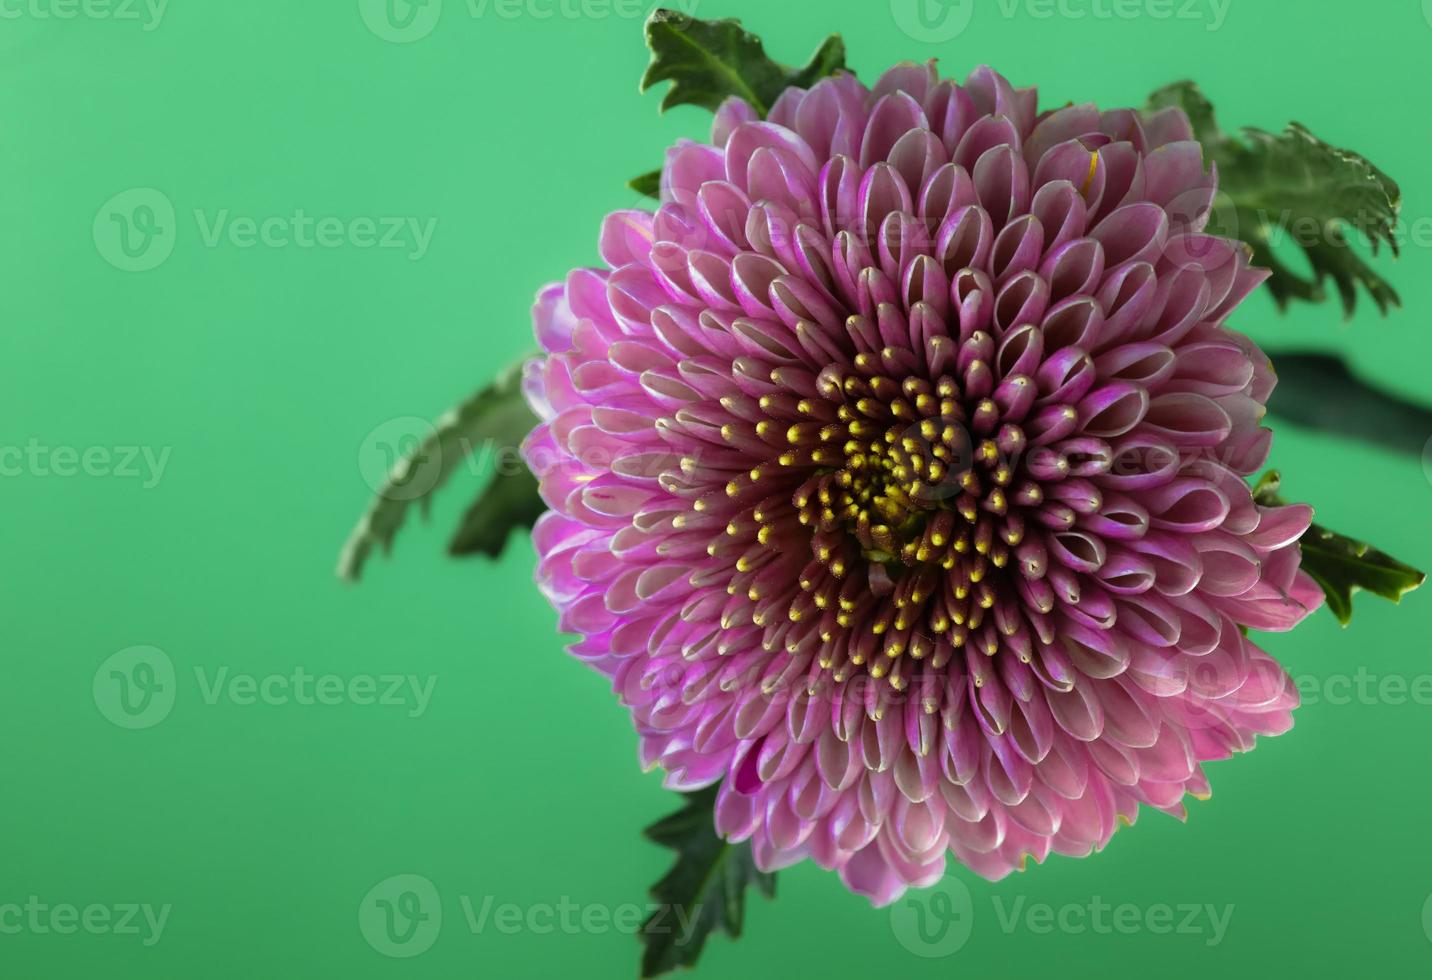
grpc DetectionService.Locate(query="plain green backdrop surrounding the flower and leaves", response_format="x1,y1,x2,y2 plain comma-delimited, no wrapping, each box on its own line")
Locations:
0,0,1432,979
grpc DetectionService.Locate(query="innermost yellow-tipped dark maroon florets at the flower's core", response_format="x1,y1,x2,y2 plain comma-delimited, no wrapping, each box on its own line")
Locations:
750,365,1042,688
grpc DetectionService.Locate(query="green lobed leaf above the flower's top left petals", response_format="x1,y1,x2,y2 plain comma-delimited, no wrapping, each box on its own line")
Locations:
642,9,845,116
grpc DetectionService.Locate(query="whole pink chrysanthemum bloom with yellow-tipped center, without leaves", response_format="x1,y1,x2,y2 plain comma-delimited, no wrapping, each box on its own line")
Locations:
526,64,1320,904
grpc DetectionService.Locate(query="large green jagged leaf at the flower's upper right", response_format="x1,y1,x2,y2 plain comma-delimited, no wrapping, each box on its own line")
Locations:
1148,82,1402,317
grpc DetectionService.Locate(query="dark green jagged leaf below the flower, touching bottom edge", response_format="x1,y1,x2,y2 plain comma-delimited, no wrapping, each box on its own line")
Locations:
640,787,776,977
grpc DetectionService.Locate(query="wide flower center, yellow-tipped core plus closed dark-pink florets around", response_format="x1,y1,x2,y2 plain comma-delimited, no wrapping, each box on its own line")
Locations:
698,325,1087,693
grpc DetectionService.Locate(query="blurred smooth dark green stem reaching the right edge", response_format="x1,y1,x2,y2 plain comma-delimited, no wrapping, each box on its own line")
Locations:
1267,354,1432,454
